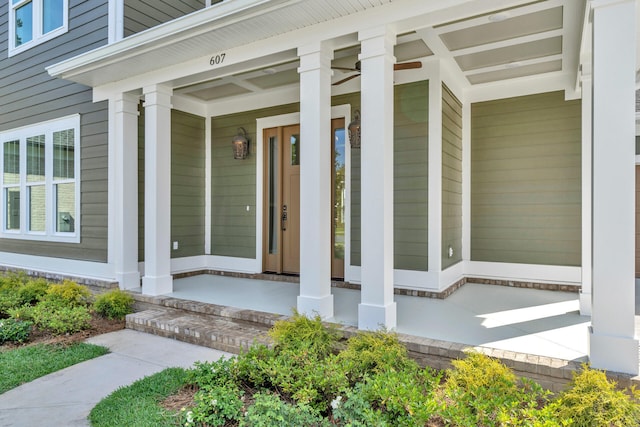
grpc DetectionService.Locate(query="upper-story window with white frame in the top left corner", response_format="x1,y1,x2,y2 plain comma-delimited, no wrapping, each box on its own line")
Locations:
9,0,69,56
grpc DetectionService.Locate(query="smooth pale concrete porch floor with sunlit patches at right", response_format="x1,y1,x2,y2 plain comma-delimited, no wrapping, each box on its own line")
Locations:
166,274,590,361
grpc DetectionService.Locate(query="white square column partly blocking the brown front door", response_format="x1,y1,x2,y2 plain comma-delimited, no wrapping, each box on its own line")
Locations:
298,42,333,318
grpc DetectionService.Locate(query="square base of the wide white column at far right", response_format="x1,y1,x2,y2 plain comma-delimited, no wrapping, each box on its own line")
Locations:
589,327,640,375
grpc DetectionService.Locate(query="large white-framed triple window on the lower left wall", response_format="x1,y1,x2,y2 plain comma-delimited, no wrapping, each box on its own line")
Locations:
0,115,80,242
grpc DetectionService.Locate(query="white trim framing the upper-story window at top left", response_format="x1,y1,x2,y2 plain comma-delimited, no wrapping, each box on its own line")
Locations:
7,0,69,57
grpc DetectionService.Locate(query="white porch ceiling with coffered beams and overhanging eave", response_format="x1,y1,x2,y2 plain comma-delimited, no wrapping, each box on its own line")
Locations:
48,0,586,101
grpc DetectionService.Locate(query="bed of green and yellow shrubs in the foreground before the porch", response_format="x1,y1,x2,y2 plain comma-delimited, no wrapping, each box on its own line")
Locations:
90,314,640,427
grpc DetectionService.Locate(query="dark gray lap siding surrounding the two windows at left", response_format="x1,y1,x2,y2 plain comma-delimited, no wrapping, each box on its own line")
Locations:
0,0,108,262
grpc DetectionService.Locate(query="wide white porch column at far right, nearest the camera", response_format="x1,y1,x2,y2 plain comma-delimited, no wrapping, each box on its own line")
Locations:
589,0,638,374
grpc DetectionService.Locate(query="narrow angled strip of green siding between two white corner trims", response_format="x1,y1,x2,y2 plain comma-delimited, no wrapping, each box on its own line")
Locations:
442,85,462,270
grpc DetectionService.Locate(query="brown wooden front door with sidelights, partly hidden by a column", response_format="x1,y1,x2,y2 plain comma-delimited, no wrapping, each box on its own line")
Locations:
263,119,345,278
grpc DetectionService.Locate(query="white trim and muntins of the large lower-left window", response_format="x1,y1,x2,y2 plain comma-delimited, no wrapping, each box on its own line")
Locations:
0,114,81,243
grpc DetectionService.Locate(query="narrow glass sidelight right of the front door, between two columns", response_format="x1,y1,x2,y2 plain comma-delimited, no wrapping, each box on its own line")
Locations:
333,129,346,259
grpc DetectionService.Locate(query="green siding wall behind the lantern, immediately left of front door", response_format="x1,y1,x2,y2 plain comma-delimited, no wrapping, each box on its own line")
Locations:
211,104,299,258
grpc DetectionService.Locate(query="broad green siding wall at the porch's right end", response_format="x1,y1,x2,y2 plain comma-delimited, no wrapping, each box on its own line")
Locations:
471,92,581,266
